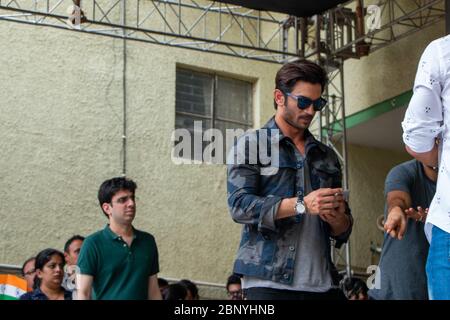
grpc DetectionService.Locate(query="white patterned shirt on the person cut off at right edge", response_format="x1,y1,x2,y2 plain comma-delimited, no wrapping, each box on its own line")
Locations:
402,36,450,242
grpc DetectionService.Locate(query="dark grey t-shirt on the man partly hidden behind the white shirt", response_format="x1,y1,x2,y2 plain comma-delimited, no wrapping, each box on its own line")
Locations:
369,160,436,300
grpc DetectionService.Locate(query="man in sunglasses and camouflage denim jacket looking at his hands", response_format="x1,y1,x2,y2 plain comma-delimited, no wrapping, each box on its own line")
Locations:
228,61,353,300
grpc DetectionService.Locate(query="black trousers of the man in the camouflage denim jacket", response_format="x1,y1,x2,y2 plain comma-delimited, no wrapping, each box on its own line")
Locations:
244,287,347,301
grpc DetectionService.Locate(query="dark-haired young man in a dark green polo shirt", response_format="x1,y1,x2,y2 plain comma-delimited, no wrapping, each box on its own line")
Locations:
77,178,161,300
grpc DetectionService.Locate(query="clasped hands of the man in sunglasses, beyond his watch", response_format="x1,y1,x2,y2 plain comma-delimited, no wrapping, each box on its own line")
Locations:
303,188,344,218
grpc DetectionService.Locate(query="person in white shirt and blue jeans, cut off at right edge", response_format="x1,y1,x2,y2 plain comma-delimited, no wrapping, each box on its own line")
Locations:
402,36,450,300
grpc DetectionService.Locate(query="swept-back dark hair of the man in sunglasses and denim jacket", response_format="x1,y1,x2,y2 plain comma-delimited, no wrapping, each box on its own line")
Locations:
274,60,328,109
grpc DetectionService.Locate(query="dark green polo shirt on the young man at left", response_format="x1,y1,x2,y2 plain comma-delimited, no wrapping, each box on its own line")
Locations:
78,225,159,300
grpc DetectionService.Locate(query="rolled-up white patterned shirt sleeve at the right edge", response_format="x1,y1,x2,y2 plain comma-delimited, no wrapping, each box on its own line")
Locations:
402,41,445,153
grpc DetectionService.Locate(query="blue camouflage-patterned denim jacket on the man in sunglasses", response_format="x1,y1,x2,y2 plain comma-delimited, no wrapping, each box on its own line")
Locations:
227,118,353,284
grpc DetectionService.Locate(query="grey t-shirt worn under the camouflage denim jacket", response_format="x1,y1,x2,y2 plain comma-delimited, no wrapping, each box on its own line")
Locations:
243,156,333,292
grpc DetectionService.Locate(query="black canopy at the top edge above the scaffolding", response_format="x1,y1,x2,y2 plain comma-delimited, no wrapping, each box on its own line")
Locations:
211,0,348,17
